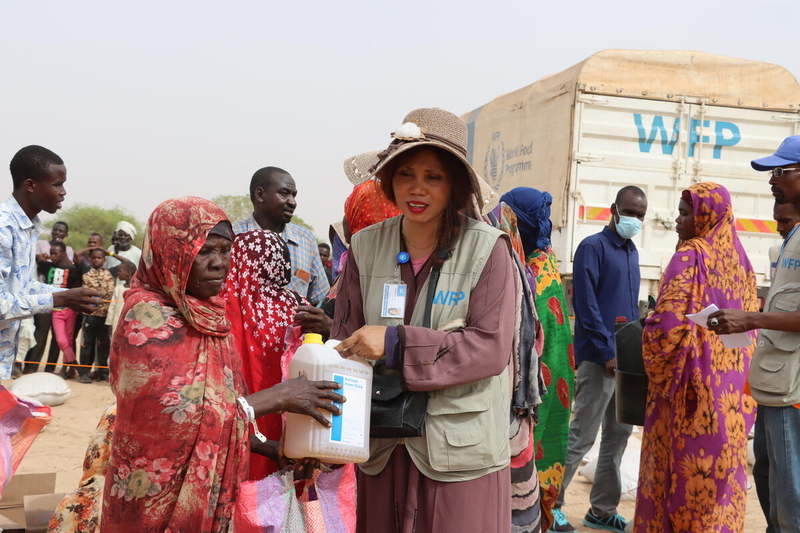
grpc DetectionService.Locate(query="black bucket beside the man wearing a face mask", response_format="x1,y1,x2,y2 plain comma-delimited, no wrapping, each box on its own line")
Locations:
615,320,647,426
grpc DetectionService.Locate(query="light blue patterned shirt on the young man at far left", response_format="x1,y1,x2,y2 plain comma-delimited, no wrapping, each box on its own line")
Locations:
0,196,61,379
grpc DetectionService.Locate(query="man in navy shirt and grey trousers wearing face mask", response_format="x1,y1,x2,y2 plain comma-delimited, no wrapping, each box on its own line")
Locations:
551,186,647,533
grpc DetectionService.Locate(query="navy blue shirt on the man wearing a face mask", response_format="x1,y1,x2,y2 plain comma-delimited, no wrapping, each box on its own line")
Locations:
572,226,641,364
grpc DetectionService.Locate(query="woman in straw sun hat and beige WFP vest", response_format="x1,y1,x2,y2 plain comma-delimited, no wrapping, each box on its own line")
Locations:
331,109,519,533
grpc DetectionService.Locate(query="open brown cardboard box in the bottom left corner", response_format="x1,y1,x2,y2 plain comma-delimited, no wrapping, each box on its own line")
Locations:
0,472,64,533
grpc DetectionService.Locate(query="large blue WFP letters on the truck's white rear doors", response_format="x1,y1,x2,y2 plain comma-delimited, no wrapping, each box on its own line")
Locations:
633,113,742,159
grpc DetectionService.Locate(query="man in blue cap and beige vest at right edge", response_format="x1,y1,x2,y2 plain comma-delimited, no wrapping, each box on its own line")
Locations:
707,135,800,533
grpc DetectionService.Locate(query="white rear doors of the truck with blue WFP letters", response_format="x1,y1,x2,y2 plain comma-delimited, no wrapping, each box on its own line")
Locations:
572,93,796,292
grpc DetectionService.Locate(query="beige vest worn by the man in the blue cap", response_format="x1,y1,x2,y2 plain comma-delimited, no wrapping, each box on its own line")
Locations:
749,231,800,407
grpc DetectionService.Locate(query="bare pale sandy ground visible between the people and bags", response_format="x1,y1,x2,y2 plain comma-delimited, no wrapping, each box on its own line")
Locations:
3,374,766,533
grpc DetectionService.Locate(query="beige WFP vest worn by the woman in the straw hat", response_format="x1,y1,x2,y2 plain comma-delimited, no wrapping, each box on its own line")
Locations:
351,217,511,481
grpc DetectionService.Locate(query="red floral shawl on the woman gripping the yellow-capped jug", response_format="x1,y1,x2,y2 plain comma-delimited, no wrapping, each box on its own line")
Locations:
102,197,249,533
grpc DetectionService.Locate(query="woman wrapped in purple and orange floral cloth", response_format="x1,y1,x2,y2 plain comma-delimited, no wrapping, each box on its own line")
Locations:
635,183,758,533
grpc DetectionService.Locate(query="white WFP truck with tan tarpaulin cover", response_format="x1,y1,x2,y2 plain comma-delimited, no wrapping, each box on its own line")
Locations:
462,50,800,310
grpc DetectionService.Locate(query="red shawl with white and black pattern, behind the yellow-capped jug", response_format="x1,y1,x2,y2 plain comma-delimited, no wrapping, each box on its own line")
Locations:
226,230,308,480
